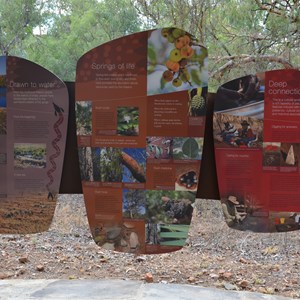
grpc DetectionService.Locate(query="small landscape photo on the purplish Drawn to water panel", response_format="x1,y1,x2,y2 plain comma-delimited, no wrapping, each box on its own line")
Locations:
14,143,46,169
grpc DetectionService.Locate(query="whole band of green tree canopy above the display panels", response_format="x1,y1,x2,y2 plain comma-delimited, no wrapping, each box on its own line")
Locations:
0,0,300,88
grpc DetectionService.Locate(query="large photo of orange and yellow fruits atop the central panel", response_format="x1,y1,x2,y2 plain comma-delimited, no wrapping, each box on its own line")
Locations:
147,27,208,95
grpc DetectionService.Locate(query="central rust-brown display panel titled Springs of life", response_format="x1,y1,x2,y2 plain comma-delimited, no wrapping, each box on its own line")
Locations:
76,28,208,254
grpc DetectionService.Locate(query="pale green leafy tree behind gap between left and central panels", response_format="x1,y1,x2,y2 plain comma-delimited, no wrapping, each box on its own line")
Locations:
26,0,140,80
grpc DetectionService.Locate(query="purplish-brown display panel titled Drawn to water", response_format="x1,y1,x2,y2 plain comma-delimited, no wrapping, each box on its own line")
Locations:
0,56,69,233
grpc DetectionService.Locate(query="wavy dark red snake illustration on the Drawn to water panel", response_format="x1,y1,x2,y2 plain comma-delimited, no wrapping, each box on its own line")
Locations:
46,103,64,200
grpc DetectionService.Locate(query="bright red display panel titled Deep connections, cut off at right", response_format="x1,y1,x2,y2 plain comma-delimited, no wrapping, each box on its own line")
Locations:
213,70,300,232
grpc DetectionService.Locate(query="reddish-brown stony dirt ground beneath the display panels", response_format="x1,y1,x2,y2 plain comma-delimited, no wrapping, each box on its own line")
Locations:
0,195,300,299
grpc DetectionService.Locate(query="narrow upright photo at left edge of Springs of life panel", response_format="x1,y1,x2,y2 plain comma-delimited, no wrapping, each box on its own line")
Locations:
75,101,92,135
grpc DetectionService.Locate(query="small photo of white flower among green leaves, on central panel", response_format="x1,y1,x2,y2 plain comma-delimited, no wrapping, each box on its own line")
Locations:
117,106,139,136
